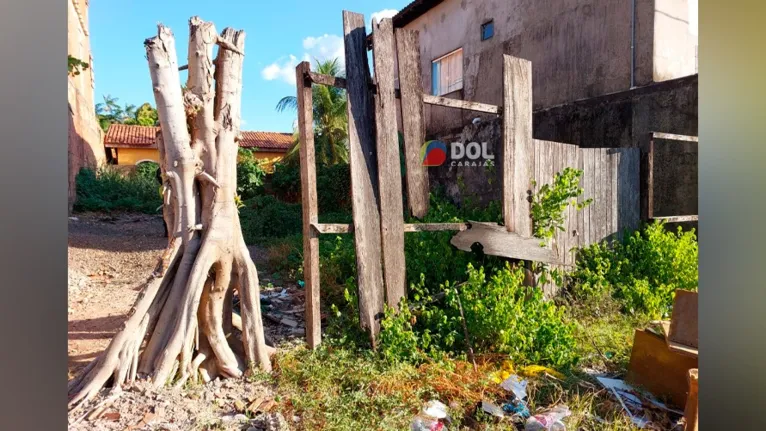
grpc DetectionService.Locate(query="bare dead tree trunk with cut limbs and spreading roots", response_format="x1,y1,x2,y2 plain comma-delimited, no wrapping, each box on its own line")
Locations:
69,17,271,409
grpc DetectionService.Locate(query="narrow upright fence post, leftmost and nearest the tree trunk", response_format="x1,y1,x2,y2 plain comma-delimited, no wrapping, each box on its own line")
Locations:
295,61,322,349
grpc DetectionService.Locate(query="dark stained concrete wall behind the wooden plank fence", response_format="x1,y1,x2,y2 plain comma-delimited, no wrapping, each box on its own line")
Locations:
428,75,698,216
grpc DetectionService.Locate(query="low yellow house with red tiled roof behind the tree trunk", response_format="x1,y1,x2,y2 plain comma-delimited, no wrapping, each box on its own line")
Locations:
104,124,293,170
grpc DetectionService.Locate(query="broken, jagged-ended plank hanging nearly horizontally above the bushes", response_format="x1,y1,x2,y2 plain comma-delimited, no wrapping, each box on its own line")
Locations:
450,223,559,263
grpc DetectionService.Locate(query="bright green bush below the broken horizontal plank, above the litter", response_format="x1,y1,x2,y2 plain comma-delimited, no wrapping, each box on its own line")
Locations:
380,264,578,369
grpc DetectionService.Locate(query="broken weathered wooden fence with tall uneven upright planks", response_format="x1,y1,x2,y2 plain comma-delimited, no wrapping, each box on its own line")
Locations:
296,11,640,348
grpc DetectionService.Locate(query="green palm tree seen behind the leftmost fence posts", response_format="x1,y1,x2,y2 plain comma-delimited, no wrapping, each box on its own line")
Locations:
276,58,348,164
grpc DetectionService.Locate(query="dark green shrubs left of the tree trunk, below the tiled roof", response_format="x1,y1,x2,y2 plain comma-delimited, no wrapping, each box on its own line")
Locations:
74,163,162,214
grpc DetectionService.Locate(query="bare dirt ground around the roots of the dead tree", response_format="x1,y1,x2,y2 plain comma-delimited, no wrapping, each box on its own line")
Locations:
68,214,303,431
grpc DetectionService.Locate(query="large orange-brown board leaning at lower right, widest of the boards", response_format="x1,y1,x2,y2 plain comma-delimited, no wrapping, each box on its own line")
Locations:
626,330,697,409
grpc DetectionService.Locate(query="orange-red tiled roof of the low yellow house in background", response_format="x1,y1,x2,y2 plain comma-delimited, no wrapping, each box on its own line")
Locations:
104,124,293,152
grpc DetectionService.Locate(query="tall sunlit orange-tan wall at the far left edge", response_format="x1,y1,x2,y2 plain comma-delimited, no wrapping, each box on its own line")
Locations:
67,0,106,212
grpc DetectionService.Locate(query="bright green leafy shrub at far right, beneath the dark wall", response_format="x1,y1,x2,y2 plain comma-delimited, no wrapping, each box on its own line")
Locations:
570,221,698,318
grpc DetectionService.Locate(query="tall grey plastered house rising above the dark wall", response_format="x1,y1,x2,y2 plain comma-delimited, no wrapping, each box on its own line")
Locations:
393,0,698,134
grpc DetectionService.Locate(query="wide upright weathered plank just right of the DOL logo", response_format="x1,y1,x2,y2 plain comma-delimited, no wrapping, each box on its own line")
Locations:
501,55,535,237
